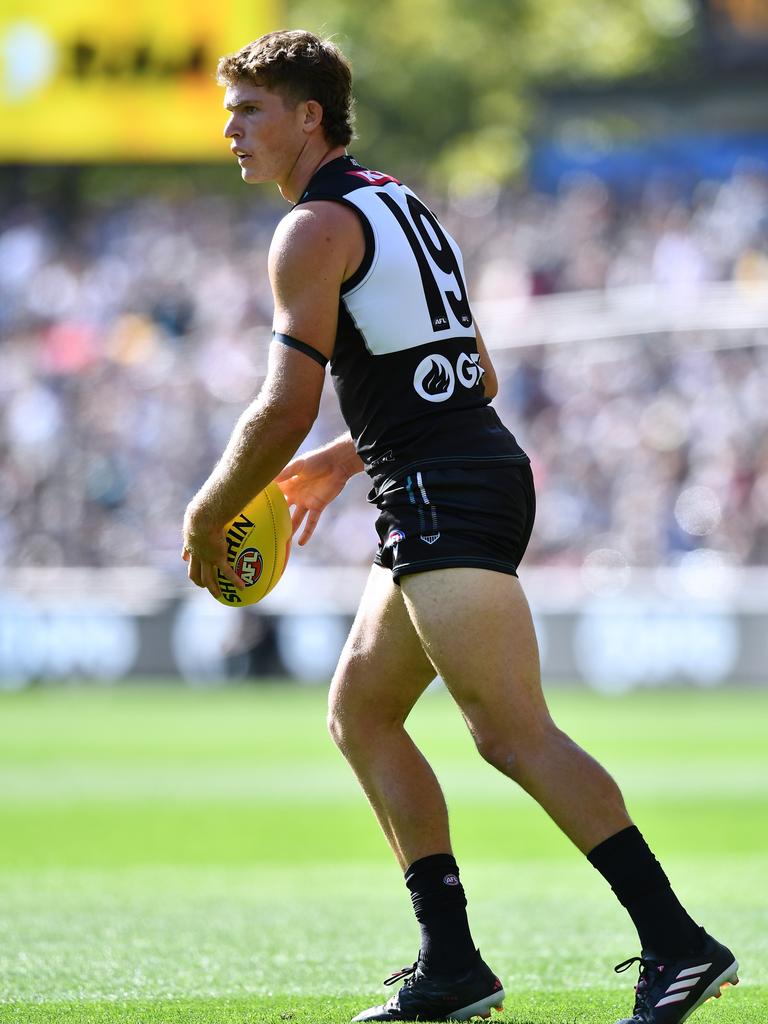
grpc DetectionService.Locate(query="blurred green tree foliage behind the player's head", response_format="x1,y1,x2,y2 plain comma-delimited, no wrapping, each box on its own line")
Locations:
288,0,693,194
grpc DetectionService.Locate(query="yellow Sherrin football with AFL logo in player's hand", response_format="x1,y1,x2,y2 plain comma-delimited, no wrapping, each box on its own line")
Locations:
216,483,291,608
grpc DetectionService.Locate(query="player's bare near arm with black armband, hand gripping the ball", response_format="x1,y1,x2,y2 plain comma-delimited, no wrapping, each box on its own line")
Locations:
182,203,359,596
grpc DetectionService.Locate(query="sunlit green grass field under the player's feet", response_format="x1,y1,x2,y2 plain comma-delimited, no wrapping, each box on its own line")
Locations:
0,686,768,1024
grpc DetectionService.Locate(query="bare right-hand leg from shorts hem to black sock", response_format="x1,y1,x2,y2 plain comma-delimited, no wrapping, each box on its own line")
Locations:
387,568,631,853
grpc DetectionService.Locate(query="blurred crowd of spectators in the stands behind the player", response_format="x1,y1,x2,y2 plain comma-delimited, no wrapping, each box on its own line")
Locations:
0,162,768,571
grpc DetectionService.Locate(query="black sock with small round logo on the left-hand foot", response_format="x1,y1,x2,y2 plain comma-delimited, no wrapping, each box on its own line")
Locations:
406,853,476,977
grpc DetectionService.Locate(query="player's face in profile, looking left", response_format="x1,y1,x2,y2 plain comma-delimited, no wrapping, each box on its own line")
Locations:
224,82,306,184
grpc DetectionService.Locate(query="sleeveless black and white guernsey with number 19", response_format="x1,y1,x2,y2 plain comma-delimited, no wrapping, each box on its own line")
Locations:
299,156,528,489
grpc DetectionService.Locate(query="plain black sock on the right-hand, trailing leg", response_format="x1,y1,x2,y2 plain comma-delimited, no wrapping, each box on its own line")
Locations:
587,825,705,957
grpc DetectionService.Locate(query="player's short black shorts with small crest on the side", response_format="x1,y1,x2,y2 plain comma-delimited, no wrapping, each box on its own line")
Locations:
375,462,536,583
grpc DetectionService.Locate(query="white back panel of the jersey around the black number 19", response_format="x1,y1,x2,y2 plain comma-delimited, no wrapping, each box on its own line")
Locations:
342,181,475,355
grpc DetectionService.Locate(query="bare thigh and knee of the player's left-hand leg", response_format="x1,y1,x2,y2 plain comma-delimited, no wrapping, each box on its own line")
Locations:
329,565,436,735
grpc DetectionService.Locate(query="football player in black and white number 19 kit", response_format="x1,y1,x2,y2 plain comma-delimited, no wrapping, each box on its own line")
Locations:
183,32,737,1024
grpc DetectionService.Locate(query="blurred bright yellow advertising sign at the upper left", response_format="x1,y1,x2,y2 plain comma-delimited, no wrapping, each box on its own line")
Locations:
0,0,283,163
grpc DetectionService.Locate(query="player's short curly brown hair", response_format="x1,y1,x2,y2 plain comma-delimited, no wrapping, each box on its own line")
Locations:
216,29,353,145
